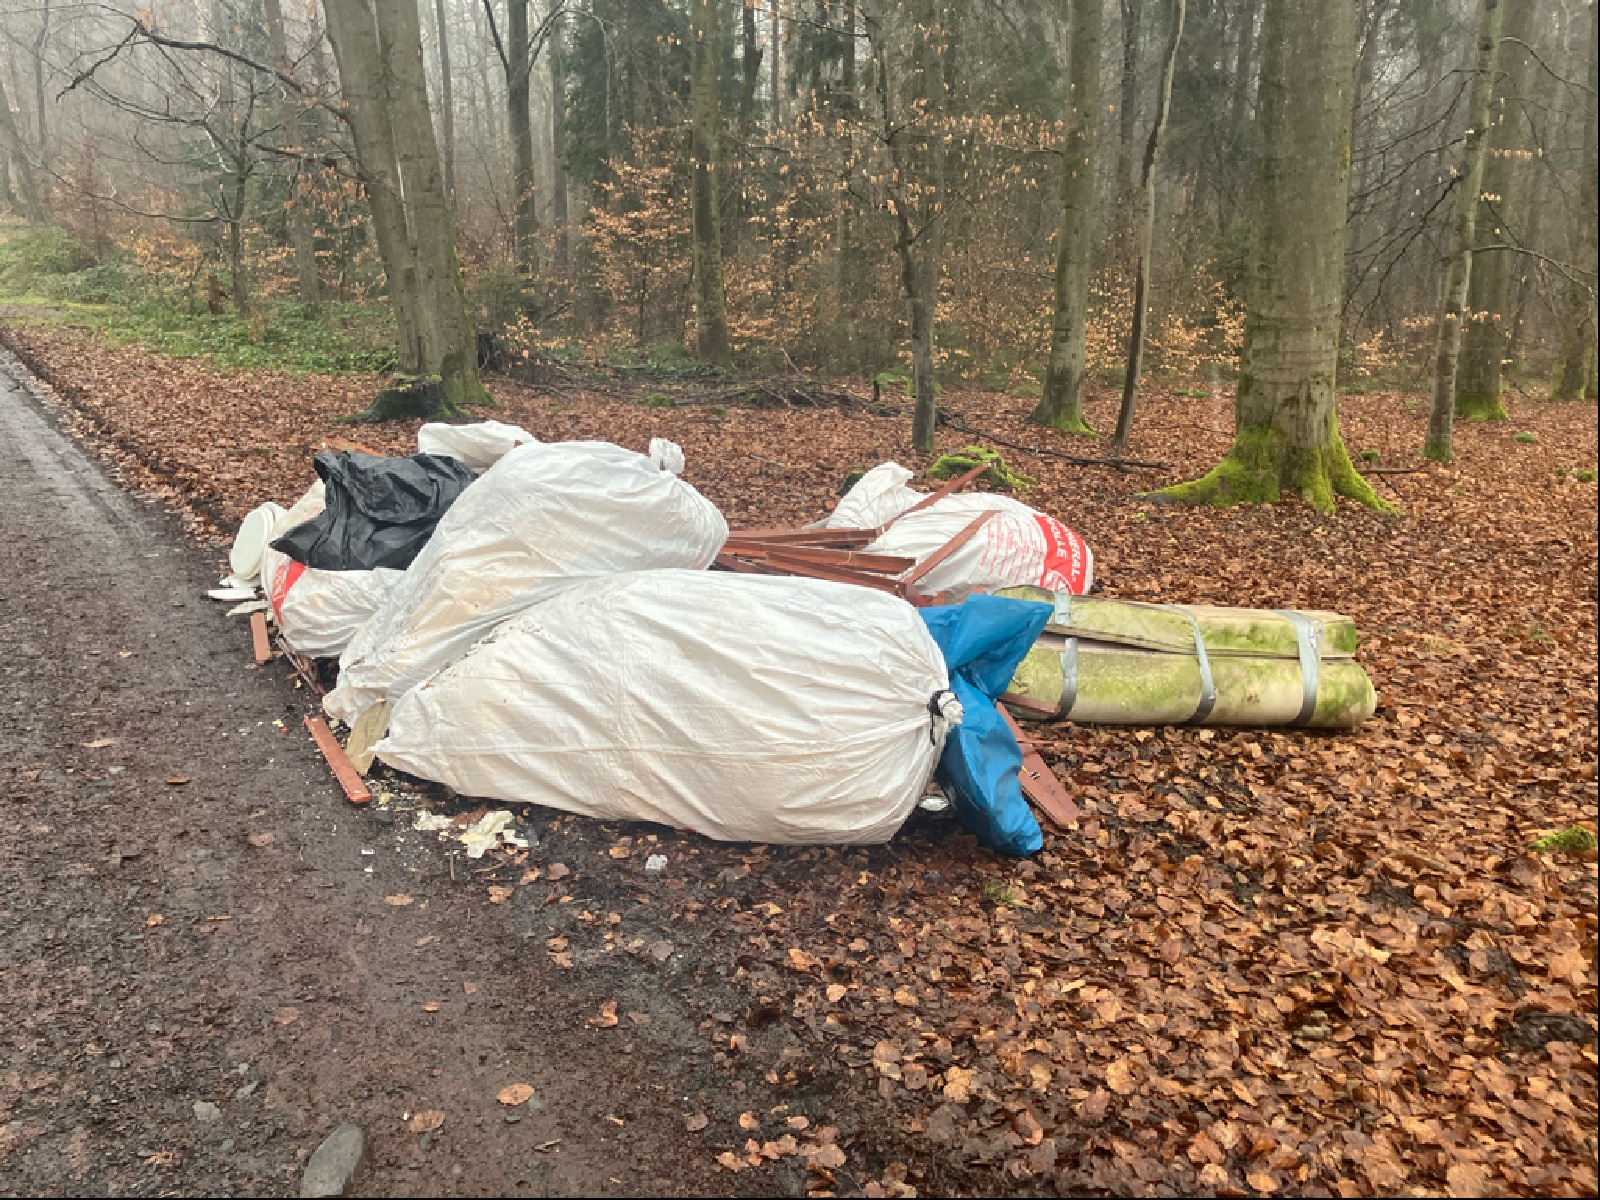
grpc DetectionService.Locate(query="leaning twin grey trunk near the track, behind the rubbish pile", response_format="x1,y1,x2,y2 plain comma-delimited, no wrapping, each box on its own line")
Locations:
325,0,491,414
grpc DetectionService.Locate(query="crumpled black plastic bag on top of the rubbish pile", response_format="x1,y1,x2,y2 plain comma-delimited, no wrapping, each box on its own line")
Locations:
272,450,477,571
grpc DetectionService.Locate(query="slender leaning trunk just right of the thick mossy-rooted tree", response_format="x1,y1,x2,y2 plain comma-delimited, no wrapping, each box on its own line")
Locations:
1456,0,1539,421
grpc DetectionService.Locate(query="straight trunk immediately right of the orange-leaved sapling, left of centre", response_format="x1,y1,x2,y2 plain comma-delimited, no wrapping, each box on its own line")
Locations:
690,0,731,366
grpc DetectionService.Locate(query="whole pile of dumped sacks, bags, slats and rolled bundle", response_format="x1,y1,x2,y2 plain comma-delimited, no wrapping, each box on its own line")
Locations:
211,421,1376,854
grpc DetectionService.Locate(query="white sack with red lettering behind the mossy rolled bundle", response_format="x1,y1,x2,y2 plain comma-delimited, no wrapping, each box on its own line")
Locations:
821,462,1094,595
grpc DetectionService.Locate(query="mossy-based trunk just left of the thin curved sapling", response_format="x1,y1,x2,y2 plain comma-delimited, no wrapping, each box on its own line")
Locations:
1030,0,1102,434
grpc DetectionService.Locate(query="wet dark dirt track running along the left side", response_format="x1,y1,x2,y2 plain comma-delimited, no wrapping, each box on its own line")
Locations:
0,355,717,1195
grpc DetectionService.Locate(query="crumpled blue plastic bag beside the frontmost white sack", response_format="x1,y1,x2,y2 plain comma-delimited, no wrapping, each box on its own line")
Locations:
918,595,1054,858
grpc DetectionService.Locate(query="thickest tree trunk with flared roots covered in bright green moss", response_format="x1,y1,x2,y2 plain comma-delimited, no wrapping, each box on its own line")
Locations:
1152,0,1389,512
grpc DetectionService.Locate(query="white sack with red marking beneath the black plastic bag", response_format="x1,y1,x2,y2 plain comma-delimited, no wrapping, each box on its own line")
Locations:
261,480,405,658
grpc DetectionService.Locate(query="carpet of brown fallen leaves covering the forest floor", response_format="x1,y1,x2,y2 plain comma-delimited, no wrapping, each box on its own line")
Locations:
13,328,1600,1195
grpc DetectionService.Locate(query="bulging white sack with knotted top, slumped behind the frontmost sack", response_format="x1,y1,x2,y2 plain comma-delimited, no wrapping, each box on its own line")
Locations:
323,442,728,725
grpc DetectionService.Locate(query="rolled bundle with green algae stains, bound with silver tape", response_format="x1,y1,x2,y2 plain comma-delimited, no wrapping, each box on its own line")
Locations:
1000,587,1378,730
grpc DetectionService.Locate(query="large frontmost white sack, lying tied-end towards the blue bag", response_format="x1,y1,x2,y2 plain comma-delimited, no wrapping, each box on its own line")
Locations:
373,571,960,843
